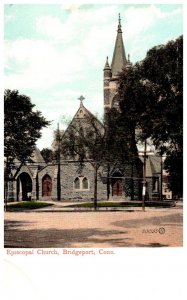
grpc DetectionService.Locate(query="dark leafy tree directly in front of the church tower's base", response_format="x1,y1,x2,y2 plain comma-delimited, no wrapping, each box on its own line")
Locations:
104,108,141,199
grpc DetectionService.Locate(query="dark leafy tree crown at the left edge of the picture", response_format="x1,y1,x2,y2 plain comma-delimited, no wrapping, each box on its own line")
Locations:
4,90,50,162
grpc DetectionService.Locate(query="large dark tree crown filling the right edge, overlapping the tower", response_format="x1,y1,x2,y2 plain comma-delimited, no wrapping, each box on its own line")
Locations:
119,37,183,197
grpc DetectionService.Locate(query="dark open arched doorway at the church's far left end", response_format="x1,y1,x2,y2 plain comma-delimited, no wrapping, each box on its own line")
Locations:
17,172,32,201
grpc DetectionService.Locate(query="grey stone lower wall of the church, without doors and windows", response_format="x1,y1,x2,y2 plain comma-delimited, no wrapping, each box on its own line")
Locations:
8,157,160,201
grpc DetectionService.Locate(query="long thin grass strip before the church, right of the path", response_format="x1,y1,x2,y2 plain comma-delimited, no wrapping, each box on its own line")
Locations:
66,202,175,208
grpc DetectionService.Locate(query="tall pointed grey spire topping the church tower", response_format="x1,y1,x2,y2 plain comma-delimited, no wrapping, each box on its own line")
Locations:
111,14,127,78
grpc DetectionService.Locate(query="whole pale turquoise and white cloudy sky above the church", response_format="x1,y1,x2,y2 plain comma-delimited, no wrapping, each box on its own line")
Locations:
4,3,183,150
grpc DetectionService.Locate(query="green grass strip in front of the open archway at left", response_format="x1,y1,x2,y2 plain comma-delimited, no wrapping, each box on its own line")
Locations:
7,201,53,211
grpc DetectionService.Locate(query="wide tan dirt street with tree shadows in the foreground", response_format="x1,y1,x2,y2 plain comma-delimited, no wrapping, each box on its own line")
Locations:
4,206,183,248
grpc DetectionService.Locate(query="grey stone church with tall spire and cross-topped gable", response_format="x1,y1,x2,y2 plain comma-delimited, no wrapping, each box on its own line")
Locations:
8,17,161,201
